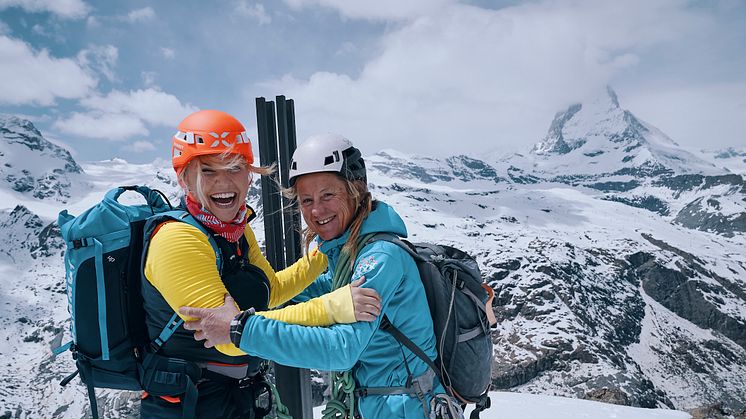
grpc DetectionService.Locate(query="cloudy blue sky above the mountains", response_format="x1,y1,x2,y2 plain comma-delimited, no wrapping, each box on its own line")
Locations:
0,0,746,162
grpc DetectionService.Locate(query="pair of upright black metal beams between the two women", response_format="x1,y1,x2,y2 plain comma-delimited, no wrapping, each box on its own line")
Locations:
256,96,313,419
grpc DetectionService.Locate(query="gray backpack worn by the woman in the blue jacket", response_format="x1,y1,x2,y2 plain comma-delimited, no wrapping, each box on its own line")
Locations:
368,234,496,417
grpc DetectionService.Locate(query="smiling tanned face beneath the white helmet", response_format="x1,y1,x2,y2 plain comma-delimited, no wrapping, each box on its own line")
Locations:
295,172,356,241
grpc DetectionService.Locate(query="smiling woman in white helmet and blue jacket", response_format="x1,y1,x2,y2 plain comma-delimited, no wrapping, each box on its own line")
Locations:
181,135,460,418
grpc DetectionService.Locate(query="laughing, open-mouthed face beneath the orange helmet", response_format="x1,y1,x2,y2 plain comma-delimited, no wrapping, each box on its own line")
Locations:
184,155,251,223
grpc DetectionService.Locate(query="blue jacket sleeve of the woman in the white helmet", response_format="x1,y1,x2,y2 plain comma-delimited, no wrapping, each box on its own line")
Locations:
240,246,404,371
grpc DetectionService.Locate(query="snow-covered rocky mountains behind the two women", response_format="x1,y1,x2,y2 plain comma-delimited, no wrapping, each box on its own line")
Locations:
0,97,746,418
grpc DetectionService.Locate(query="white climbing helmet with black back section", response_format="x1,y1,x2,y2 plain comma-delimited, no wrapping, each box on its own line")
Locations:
289,134,367,186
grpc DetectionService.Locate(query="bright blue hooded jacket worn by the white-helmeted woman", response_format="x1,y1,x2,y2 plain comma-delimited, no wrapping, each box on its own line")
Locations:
240,201,444,418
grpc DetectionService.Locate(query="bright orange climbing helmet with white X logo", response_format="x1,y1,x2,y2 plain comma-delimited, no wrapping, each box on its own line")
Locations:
171,110,254,174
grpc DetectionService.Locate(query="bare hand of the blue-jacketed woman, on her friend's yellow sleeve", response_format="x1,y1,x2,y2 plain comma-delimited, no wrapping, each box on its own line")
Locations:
179,294,239,348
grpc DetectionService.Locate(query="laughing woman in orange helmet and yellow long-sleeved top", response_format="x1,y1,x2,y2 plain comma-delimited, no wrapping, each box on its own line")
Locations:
141,110,380,419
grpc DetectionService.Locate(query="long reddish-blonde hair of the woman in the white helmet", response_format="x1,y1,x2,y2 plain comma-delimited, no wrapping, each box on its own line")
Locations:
284,175,373,265
